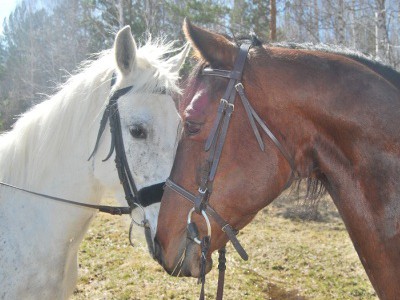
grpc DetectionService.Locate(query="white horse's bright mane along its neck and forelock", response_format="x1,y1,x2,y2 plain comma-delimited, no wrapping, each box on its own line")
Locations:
0,40,179,185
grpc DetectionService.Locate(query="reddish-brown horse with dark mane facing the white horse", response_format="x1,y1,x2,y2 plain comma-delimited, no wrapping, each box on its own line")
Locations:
155,22,400,300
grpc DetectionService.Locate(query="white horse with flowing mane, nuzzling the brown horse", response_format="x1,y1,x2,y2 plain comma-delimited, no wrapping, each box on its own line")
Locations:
0,27,187,299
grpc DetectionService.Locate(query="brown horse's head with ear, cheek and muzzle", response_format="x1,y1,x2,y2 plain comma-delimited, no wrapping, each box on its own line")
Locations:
156,22,291,277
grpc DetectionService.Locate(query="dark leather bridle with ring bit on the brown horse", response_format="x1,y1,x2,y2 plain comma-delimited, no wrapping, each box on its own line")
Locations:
166,43,295,299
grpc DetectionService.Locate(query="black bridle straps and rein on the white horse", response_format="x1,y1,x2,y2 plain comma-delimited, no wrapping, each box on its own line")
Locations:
0,73,154,250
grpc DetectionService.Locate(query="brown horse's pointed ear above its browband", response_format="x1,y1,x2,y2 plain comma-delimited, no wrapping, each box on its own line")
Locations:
183,18,237,68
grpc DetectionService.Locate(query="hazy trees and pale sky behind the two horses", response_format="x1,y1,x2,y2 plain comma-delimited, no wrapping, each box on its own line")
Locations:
0,0,400,130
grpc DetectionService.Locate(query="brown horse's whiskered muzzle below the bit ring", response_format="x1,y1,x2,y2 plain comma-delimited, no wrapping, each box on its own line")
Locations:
154,236,212,278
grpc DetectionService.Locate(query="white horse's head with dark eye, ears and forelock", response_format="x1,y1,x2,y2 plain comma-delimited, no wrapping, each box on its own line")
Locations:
94,26,188,244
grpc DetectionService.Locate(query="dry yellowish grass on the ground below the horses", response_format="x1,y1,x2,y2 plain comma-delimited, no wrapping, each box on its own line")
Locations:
73,192,377,300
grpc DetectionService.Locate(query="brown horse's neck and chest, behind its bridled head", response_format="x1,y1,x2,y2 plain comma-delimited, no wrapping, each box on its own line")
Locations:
249,49,400,299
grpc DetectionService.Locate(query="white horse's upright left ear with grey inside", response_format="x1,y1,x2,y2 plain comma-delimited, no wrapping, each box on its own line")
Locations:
114,26,137,75
